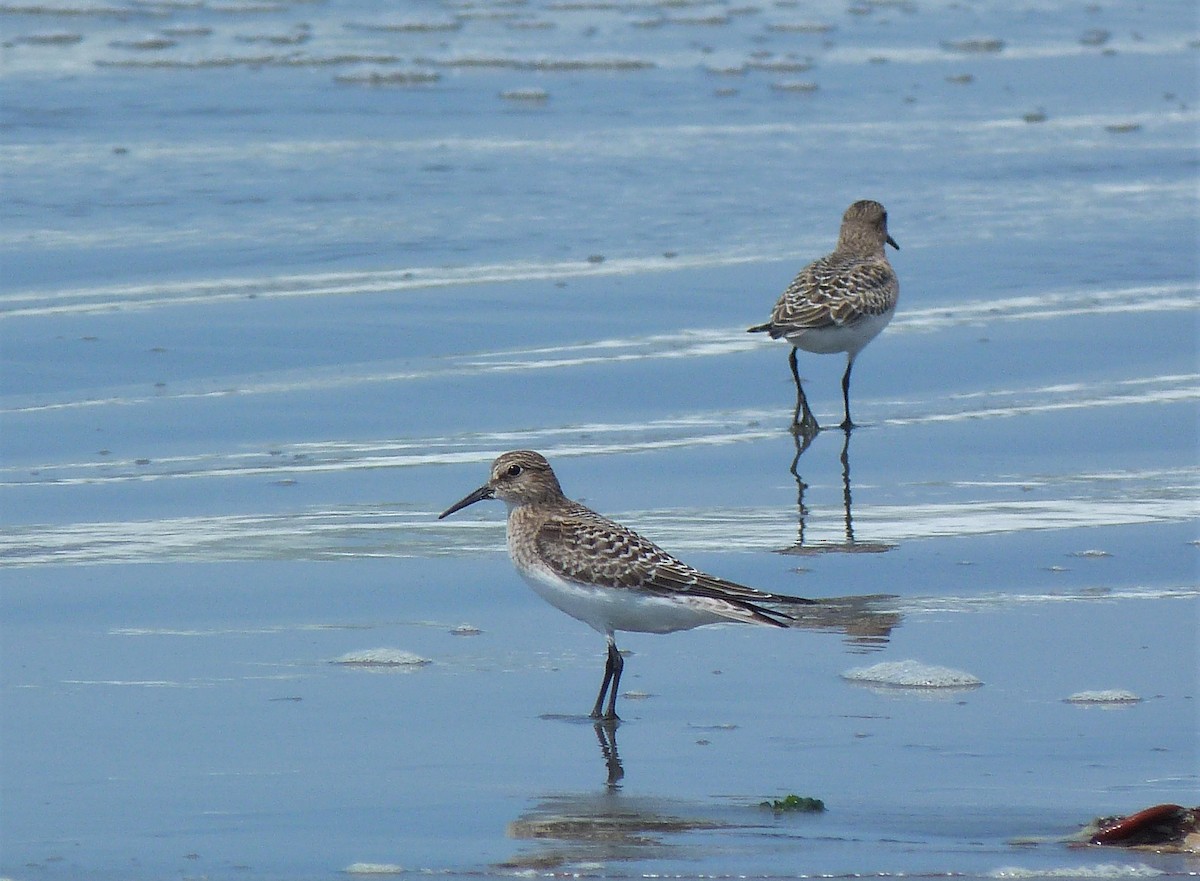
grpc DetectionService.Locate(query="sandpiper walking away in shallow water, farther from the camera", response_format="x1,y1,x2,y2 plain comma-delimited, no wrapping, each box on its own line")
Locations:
749,199,900,436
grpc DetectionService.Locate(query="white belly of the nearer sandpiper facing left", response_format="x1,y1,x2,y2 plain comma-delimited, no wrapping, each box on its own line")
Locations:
521,568,728,634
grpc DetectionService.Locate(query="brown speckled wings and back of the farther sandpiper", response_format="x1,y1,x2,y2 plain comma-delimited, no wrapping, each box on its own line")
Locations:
770,253,899,338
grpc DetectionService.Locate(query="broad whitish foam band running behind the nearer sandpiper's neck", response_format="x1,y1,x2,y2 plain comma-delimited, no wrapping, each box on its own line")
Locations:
0,465,1200,567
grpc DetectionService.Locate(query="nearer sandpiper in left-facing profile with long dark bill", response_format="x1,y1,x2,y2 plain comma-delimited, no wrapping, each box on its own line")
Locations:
438,450,814,720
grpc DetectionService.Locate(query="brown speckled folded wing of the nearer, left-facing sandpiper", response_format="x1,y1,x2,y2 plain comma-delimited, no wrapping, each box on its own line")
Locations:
536,505,809,624
